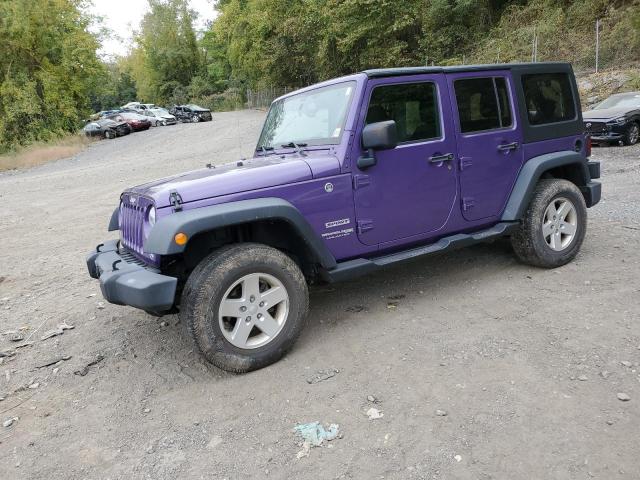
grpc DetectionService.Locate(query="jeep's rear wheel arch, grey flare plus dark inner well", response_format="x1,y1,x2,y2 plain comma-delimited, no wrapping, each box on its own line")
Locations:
501,151,594,222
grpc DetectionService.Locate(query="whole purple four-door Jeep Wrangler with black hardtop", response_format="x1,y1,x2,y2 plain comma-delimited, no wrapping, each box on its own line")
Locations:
87,63,600,372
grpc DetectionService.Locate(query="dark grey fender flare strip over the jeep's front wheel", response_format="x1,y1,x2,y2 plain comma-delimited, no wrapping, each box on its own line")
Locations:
144,198,336,269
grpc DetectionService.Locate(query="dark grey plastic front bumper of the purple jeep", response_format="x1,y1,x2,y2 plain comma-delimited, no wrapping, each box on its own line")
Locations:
87,240,178,312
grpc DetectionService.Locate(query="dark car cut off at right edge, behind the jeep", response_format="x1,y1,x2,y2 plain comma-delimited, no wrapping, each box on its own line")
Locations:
582,92,640,145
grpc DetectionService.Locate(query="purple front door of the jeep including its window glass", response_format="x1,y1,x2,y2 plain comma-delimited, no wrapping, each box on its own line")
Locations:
354,74,457,245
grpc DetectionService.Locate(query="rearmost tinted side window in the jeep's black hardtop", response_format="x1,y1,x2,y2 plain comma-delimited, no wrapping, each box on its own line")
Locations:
522,73,576,125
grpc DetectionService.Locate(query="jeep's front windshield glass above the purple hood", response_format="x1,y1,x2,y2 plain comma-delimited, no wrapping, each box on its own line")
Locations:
258,82,356,149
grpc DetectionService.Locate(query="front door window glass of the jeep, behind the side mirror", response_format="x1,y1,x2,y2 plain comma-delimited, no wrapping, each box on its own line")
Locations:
366,82,441,143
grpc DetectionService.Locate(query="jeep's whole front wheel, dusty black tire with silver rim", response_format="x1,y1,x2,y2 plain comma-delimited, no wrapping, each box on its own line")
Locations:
180,243,309,373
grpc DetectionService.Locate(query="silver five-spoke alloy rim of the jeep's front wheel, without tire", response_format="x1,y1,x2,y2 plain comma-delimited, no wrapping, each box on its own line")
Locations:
218,273,289,349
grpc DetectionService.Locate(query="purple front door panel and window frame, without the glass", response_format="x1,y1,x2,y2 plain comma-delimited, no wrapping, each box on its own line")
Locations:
351,74,457,246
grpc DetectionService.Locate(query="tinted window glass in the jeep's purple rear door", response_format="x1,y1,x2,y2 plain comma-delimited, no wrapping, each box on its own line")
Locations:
454,77,512,133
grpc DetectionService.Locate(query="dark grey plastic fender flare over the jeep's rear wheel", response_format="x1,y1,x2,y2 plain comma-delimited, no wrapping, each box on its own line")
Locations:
500,151,591,222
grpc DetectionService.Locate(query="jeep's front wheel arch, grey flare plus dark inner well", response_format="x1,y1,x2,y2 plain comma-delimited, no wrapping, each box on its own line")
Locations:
144,198,336,269
